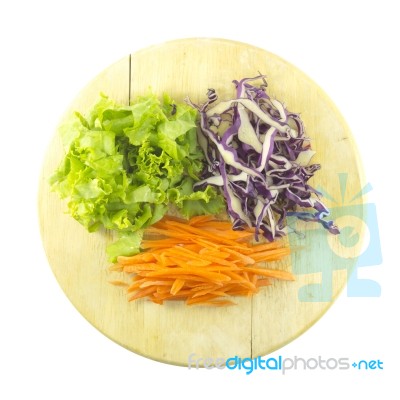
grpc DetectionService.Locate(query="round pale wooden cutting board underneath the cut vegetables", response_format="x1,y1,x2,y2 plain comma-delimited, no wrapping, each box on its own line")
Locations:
39,39,363,365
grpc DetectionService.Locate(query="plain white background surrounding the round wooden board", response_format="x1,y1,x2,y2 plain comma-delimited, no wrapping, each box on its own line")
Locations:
0,0,400,399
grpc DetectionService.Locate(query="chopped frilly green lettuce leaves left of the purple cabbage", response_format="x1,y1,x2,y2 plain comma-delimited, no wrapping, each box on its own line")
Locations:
50,94,224,255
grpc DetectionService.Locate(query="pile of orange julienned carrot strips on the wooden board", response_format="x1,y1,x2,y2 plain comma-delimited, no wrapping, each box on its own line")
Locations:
110,216,294,306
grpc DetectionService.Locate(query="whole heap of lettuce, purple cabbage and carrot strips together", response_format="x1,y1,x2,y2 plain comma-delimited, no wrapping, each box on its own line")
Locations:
51,75,339,306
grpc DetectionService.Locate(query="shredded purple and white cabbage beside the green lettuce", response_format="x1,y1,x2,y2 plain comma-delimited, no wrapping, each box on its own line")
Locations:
186,75,339,241
